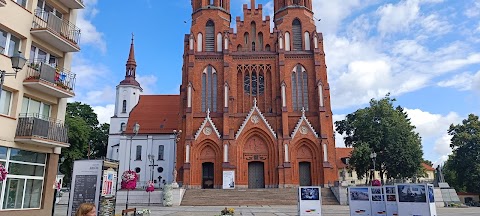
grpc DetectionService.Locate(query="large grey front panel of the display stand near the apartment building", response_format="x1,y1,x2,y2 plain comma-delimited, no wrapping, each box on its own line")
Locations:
67,160,103,216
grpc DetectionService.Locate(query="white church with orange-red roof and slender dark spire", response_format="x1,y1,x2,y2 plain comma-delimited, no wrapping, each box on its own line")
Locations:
106,38,181,188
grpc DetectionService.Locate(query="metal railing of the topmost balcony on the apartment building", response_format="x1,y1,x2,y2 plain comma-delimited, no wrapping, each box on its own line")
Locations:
32,9,80,44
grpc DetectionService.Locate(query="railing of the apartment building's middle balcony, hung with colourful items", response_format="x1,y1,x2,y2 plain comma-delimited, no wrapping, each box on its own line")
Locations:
25,59,76,92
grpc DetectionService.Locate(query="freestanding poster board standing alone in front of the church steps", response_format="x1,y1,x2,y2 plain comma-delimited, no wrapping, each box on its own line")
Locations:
298,186,322,216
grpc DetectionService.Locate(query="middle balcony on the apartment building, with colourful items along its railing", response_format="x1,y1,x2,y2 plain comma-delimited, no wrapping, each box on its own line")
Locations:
23,59,75,98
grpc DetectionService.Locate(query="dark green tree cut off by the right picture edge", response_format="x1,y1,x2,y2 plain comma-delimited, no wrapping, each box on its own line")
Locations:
446,114,480,193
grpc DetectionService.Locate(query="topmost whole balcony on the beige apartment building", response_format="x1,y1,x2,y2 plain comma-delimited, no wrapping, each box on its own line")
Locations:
30,10,80,52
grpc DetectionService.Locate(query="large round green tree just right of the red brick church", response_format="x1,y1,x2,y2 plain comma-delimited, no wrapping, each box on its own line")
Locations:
335,94,423,182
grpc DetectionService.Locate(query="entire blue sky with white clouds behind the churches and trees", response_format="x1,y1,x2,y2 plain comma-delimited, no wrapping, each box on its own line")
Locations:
72,0,480,163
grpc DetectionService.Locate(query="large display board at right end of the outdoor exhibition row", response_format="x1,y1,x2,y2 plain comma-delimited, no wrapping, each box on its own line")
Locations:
395,184,437,216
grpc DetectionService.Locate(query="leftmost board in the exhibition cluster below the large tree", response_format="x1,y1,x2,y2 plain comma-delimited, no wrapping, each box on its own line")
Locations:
348,187,372,216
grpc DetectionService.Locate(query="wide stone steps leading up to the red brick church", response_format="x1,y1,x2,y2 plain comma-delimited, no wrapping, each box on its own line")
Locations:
181,188,339,206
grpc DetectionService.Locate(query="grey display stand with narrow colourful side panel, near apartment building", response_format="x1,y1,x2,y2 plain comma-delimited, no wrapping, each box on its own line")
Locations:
67,160,118,216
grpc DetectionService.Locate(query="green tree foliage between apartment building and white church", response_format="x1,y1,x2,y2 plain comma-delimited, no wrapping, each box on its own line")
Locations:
60,102,110,183
